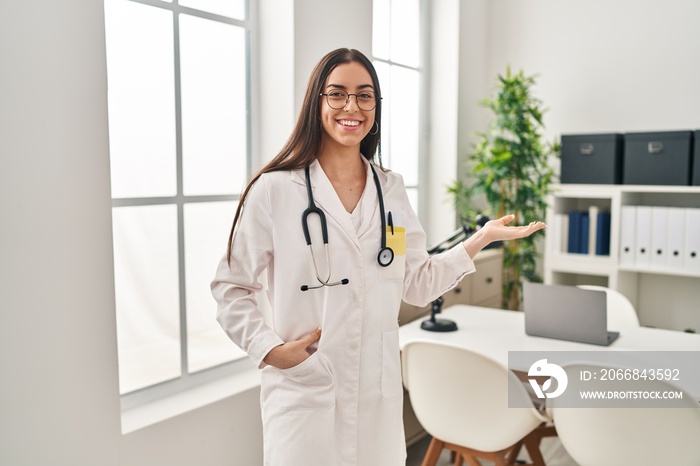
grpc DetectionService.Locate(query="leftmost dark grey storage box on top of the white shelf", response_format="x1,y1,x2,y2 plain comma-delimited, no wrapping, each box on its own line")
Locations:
561,133,623,184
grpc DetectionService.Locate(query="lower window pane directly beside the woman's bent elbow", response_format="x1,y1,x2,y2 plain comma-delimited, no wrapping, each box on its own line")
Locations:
185,202,245,373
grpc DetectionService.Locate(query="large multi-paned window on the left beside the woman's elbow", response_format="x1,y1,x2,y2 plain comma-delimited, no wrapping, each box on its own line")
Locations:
105,0,250,400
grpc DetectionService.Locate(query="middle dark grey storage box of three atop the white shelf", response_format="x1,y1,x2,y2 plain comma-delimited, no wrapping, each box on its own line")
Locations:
622,131,693,186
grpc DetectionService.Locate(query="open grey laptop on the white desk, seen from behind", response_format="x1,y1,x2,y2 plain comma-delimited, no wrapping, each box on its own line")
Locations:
523,282,620,346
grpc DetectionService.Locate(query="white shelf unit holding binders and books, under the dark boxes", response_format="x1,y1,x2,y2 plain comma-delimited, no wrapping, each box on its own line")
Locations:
544,184,700,332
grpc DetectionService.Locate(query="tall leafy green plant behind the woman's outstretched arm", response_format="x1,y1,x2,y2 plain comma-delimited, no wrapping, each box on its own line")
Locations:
448,67,559,310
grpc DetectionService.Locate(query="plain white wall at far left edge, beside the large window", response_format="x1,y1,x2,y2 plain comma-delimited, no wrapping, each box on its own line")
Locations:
0,0,120,466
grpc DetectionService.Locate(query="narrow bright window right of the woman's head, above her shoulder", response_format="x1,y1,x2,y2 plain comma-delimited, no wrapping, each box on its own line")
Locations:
372,0,425,215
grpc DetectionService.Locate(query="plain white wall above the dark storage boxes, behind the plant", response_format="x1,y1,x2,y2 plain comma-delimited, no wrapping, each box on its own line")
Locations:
468,0,700,142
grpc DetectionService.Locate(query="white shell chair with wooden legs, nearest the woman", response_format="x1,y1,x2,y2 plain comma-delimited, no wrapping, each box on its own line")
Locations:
402,341,554,466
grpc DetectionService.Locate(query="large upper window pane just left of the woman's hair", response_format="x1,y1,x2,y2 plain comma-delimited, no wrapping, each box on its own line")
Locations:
180,15,247,195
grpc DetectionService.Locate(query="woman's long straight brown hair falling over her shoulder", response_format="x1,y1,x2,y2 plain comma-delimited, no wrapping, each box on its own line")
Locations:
227,48,382,265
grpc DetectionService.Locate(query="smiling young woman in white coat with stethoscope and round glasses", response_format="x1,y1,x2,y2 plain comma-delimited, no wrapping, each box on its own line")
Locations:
212,49,544,466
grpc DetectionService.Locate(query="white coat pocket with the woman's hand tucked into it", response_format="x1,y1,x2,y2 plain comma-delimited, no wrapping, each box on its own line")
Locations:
260,351,335,410
